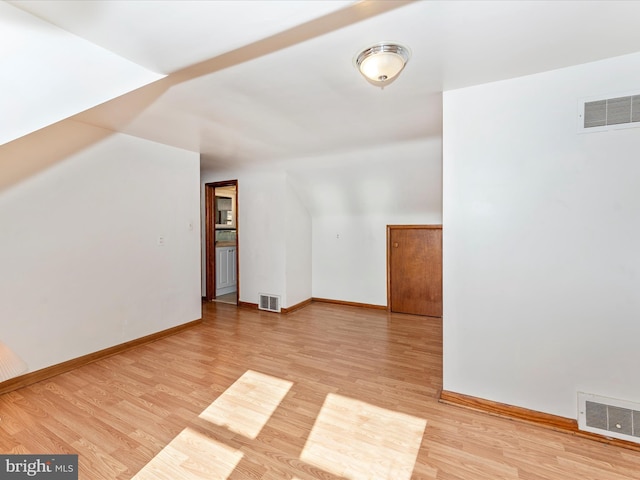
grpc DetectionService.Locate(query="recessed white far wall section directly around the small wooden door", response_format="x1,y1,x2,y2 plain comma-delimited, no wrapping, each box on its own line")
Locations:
291,138,442,305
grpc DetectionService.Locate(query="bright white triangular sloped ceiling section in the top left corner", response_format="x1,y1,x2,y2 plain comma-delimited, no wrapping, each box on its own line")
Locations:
0,2,164,145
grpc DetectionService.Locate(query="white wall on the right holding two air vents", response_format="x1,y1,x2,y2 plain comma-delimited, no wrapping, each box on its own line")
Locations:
443,54,640,418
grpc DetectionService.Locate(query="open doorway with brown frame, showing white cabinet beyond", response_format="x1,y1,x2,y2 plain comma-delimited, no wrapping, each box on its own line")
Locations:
204,180,240,305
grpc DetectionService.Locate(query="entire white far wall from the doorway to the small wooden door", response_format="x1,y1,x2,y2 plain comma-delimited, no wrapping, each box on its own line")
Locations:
202,138,442,307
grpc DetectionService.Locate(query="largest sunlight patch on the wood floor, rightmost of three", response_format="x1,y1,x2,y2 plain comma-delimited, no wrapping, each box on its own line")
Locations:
300,394,427,480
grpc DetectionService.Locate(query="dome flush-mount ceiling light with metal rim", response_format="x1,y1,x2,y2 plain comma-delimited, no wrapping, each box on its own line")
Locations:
353,42,411,88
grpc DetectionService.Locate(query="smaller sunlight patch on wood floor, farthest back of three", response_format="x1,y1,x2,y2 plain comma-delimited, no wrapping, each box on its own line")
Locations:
200,370,293,439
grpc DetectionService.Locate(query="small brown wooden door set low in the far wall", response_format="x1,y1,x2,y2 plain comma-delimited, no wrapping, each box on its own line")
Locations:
387,225,442,317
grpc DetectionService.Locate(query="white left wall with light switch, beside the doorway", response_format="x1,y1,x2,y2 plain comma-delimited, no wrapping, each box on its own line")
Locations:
0,134,201,371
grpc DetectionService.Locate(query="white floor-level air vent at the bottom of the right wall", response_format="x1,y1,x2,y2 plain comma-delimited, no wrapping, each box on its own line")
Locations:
578,393,640,443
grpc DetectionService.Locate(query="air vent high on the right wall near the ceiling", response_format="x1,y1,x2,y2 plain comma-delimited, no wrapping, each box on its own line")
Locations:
578,93,640,132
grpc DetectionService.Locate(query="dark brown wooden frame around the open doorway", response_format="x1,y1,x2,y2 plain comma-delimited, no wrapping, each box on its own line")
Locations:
203,180,240,305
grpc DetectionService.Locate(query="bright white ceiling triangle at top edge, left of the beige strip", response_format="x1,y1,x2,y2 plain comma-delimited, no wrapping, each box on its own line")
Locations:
9,0,353,74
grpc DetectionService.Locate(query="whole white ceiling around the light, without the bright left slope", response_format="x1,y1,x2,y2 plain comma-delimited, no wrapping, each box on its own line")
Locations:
6,0,640,168
